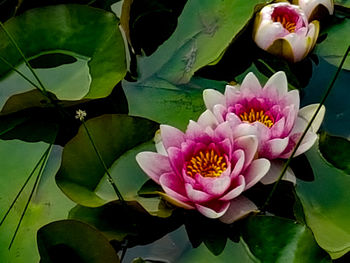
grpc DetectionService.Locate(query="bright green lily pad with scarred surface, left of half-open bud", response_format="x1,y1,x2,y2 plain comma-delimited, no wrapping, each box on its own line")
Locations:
138,0,265,84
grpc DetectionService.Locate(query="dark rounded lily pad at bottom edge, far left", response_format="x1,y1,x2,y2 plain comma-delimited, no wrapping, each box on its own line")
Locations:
38,220,119,263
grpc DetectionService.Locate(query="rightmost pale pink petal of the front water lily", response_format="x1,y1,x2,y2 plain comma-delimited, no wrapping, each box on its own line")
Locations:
244,158,270,190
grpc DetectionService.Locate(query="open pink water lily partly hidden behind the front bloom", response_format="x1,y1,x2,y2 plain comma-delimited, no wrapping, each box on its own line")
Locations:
203,71,325,183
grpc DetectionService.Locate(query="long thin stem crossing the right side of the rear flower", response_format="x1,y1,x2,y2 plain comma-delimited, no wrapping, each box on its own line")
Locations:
261,46,350,211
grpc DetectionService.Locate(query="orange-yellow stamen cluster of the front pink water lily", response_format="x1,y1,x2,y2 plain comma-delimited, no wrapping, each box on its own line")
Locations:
186,150,227,177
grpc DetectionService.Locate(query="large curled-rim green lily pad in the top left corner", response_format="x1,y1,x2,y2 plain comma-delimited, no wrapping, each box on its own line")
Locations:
0,5,126,110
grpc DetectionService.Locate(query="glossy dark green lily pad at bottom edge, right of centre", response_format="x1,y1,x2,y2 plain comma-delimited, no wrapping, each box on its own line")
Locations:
242,216,331,263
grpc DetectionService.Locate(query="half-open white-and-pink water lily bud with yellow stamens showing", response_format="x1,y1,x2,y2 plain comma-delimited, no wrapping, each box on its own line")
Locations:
253,2,319,62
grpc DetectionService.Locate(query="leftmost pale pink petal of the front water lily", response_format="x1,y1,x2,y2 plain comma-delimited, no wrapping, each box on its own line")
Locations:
136,152,172,184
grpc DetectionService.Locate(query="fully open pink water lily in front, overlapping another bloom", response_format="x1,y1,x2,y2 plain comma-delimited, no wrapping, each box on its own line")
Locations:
136,114,270,223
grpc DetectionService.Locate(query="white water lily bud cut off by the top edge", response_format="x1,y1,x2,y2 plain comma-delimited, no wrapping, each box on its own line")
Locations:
293,0,334,21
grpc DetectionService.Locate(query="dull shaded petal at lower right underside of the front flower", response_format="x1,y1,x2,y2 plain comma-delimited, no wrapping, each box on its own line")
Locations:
220,196,258,224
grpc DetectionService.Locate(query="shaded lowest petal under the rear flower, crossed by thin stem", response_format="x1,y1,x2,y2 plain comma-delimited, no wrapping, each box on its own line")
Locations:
260,160,296,184
